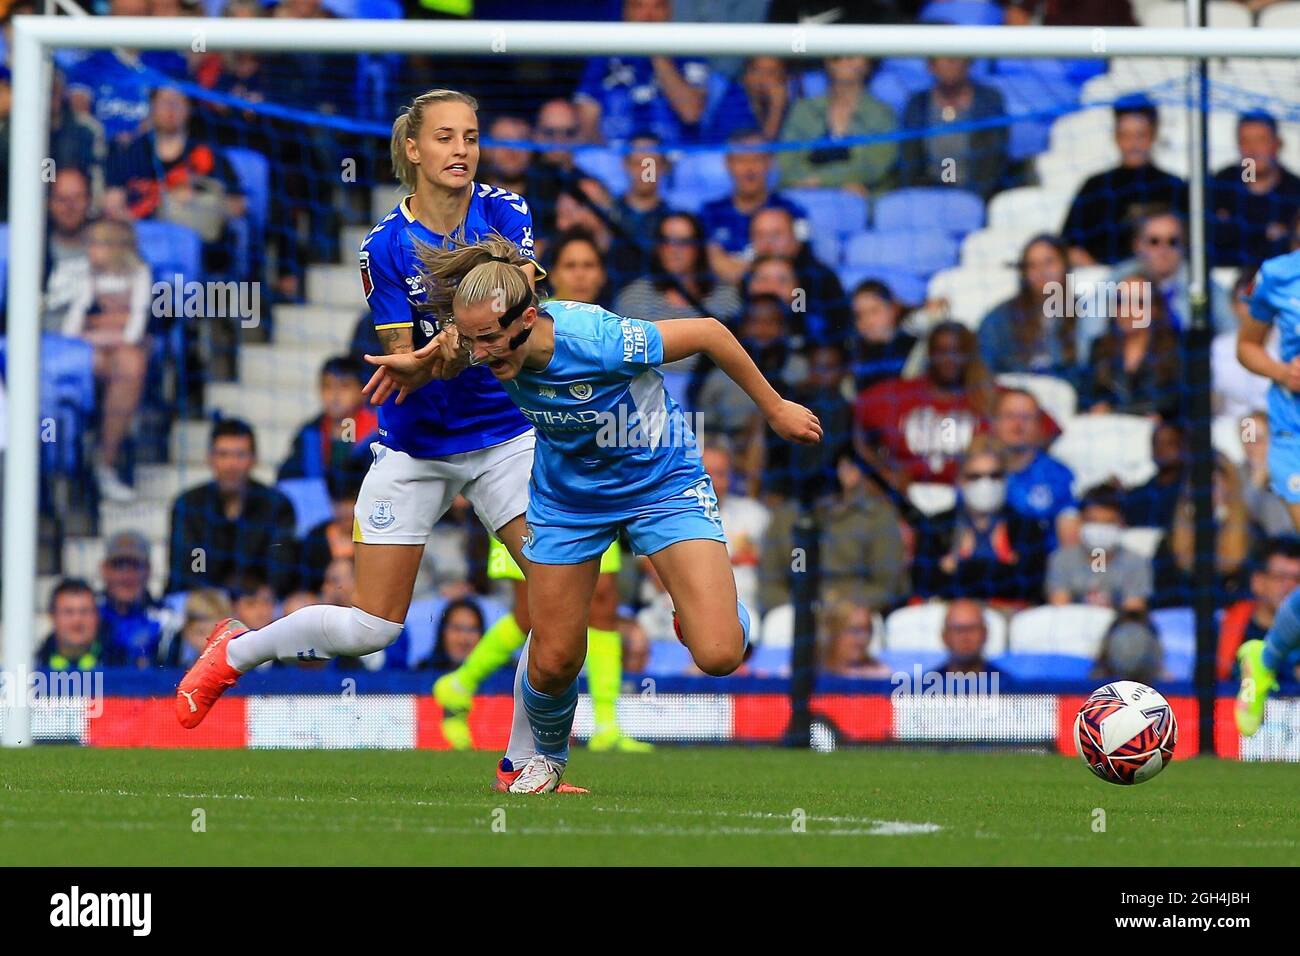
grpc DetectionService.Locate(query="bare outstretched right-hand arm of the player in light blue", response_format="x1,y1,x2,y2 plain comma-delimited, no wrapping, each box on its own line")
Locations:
655,319,822,445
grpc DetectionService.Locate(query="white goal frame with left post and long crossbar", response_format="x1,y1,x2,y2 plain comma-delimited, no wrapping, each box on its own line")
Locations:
0,9,1300,747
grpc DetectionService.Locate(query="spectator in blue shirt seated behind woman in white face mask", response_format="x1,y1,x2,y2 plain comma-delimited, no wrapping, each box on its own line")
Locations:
992,389,1079,550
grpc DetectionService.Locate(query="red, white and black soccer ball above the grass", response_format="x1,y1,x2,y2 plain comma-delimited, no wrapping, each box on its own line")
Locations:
1074,680,1178,786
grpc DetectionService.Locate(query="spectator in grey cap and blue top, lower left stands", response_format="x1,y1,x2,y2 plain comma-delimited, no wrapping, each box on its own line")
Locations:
99,531,166,667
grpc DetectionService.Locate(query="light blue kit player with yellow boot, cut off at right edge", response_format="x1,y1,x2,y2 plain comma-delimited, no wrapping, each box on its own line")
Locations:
1236,251,1300,736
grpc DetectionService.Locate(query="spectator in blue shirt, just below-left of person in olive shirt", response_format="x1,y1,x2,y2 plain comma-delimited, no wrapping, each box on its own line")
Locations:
699,130,807,284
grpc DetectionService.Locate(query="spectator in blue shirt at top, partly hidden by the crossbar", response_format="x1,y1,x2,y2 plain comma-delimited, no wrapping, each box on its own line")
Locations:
575,0,709,143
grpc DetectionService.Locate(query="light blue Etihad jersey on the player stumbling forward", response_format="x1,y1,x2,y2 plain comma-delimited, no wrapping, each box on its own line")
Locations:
506,299,705,514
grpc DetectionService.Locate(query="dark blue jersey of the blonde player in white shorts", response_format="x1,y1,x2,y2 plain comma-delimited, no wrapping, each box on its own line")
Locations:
360,182,543,458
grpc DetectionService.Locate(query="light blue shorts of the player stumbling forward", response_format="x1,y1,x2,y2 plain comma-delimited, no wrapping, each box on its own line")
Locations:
524,476,727,564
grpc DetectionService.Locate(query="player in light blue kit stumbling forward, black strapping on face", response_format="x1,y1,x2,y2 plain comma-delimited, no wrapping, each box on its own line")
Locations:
368,238,822,793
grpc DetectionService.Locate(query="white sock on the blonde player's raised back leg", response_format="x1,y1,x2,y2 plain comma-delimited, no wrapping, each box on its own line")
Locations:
226,605,402,672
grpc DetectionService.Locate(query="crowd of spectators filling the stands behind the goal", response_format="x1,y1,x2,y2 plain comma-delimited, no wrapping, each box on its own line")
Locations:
0,0,1300,679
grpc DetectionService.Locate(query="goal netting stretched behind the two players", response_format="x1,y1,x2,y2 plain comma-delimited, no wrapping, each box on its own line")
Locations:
10,20,1300,760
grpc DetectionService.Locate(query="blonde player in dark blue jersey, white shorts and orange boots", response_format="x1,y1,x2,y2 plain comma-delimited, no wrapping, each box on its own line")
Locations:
176,90,574,790
